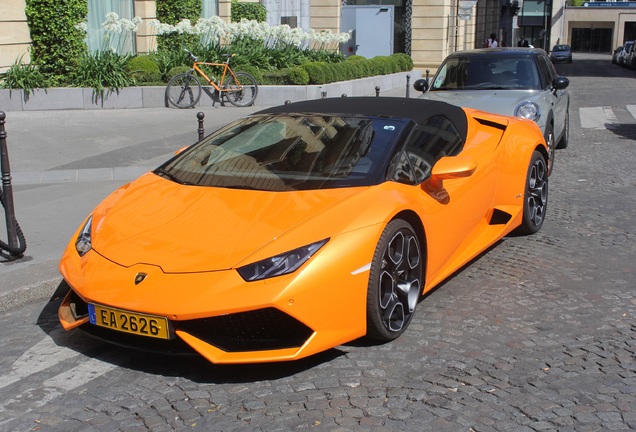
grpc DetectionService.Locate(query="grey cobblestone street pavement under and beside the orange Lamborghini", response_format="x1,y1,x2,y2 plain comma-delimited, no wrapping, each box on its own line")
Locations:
0,58,636,432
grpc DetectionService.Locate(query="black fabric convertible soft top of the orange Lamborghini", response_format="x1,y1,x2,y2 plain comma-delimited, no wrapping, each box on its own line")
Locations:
256,97,468,140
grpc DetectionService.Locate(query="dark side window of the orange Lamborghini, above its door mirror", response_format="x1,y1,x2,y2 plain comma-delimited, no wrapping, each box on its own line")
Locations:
394,115,464,183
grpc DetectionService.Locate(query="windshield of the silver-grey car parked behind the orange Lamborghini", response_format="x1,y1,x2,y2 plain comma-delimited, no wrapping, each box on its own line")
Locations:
431,55,539,91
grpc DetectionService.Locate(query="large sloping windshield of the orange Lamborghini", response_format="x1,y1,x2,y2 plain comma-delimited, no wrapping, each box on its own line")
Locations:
155,114,408,191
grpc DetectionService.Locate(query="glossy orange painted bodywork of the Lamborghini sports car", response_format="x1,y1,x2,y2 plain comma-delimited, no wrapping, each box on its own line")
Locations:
59,109,545,363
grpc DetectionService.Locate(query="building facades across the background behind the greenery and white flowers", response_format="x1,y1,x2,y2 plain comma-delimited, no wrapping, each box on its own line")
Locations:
0,0,636,72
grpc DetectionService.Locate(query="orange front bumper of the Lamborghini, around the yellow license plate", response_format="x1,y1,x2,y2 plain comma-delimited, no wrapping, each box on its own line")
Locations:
58,226,381,363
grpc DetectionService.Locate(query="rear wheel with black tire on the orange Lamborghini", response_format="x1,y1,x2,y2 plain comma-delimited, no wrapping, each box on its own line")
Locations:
517,150,548,234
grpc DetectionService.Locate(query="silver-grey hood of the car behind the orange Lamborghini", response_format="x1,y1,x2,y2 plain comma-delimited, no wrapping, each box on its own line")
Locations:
421,90,538,116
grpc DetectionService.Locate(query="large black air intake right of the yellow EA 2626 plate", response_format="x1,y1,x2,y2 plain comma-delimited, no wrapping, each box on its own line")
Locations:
173,308,313,352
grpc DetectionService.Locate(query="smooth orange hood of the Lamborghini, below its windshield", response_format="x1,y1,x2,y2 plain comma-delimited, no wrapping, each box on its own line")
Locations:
92,174,359,273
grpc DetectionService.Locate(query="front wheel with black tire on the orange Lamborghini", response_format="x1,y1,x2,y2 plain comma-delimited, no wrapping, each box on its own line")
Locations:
367,219,424,342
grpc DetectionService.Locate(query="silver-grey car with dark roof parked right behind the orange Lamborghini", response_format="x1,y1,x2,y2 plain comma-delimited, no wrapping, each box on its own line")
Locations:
413,48,570,172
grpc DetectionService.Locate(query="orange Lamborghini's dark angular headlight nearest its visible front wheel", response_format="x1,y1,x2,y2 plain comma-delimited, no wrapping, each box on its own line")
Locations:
237,239,329,282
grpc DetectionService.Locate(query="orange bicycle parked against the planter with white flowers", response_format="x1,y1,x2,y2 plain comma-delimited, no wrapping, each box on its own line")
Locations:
166,50,258,108
